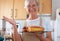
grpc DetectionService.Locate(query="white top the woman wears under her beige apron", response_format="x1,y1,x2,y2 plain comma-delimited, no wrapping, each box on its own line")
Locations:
26,17,52,31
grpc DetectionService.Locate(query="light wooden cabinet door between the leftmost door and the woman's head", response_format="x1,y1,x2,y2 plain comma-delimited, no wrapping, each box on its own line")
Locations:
14,0,26,19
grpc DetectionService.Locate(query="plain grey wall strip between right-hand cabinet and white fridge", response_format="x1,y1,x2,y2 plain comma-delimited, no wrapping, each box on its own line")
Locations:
52,0,60,20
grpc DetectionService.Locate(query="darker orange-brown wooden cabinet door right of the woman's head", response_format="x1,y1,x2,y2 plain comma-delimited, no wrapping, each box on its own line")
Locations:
39,0,52,14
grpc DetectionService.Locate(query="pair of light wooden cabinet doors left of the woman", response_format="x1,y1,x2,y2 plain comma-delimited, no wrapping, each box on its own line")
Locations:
0,0,26,19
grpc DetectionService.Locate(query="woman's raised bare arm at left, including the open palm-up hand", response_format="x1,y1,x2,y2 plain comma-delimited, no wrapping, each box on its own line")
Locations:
3,16,22,41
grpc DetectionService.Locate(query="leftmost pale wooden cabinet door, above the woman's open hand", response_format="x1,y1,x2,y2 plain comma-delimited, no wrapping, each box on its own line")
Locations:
0,0,13,19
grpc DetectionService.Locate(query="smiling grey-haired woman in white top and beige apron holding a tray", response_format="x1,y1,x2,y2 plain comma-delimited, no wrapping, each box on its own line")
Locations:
4,0,52,41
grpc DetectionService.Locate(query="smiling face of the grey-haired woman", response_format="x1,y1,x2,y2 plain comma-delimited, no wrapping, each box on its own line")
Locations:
26,1,38,14
